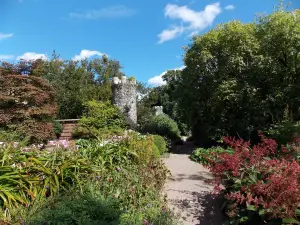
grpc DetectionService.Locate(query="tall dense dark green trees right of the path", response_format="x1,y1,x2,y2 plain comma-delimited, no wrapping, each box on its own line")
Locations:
168,9,300,143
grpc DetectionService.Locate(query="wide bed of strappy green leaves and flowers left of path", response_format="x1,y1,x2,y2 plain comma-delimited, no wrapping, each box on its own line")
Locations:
0,133,173,224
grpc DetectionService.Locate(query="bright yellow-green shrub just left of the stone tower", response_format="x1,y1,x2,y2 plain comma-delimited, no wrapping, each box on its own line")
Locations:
73,100,126,138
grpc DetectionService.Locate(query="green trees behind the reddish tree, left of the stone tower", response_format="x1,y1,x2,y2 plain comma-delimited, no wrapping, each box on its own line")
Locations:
0,52,122,119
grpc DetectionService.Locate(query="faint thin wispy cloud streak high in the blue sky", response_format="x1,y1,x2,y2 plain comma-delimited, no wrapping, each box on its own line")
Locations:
69,5,135,20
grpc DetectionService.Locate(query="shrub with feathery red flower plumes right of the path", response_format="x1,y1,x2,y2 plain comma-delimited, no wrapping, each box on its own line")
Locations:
208,133,300,224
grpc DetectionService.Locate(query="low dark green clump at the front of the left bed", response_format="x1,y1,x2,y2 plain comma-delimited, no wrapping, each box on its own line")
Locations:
28,185,121,225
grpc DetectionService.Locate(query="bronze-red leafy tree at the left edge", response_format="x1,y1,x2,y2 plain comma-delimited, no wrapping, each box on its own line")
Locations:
0,75,57,142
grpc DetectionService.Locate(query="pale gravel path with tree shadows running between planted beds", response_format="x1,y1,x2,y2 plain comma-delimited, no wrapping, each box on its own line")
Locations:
164,142,222,225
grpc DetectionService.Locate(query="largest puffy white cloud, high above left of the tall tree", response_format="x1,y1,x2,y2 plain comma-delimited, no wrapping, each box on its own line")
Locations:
158,2,222,43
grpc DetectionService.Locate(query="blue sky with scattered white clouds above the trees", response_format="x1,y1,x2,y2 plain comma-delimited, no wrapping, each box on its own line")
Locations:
0,0,300,85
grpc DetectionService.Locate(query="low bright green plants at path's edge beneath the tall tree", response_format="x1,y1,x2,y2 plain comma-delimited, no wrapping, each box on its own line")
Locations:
190,147,233,165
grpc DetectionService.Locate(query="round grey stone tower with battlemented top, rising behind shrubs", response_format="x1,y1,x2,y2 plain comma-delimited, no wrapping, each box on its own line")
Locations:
112,76,137,127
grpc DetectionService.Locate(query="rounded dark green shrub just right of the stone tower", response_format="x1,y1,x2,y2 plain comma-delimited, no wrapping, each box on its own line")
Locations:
144,114,180,141
